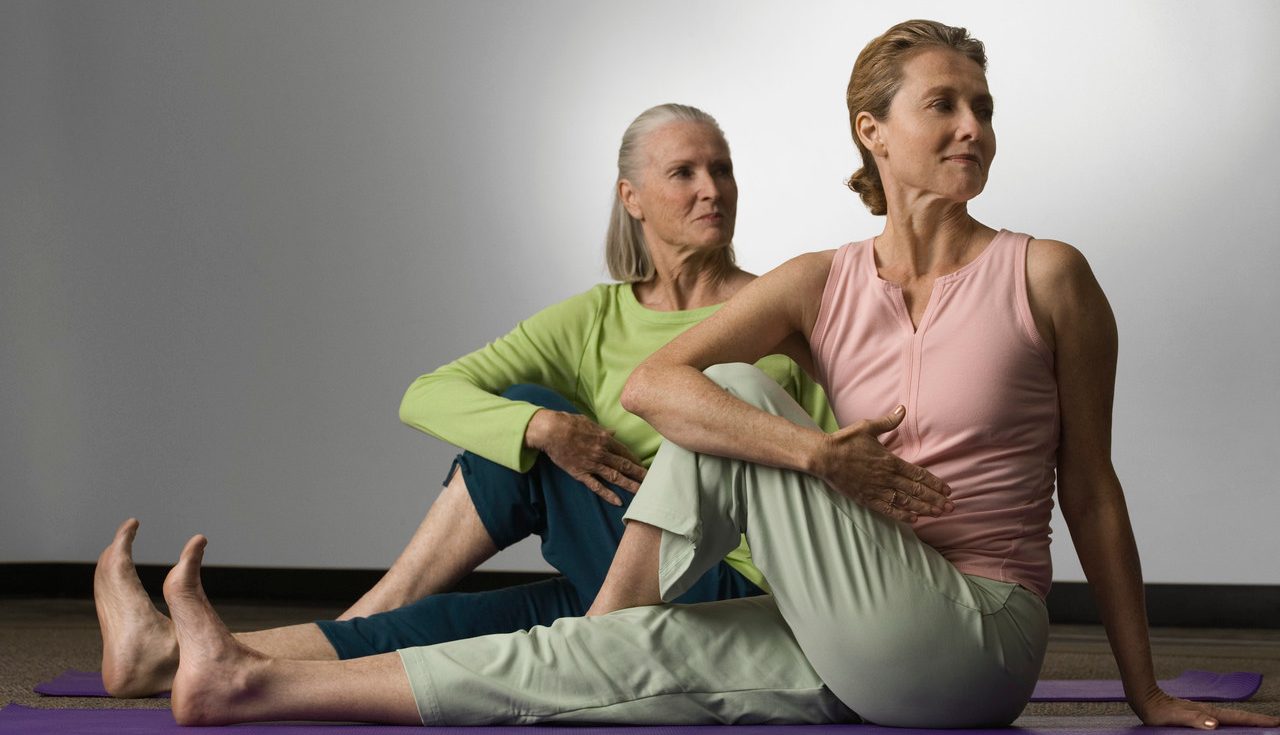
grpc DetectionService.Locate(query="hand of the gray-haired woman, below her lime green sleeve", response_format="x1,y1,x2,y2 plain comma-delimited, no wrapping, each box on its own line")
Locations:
525,408,645,506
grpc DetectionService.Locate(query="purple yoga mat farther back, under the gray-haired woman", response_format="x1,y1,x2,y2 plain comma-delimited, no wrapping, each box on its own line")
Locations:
36,670,1262,702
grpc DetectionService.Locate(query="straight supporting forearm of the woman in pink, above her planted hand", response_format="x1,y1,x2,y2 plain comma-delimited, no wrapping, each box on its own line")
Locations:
1064,493,1156,704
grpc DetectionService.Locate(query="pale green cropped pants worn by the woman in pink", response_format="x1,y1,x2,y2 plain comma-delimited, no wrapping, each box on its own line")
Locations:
399,365,1048,727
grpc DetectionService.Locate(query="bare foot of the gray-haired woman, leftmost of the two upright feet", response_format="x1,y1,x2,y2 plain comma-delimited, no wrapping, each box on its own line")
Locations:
93,519,178,697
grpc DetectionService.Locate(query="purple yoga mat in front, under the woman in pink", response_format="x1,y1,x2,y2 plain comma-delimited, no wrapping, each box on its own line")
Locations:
0,704,1280,735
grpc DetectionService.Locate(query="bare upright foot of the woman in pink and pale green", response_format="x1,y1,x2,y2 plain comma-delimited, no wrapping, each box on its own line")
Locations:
164,535,270,725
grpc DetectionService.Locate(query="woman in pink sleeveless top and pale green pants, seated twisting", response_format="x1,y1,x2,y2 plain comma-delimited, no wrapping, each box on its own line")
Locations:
99,20,1280,729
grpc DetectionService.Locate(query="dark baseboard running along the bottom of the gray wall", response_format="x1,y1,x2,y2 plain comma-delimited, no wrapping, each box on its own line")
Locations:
0,563,1280,629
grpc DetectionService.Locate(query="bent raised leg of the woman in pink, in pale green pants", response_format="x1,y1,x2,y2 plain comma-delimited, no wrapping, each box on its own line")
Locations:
593,364,1047,727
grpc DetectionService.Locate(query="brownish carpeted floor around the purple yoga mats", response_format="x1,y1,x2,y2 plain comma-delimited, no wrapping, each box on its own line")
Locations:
0,599,1280,722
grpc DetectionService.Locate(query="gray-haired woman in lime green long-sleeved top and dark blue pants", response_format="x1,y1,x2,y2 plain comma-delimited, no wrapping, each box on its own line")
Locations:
95,104,833,697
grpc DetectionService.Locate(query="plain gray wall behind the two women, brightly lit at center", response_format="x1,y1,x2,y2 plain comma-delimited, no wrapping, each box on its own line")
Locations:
0,0,1280,584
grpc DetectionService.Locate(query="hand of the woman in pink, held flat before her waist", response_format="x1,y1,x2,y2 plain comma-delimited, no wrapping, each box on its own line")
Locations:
814,406,955,524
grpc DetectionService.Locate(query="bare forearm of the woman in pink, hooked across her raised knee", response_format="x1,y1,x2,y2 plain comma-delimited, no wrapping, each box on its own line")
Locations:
622,362,827,474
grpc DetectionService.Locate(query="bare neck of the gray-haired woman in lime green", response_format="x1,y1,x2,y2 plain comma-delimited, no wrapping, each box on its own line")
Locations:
634,248,750,311
